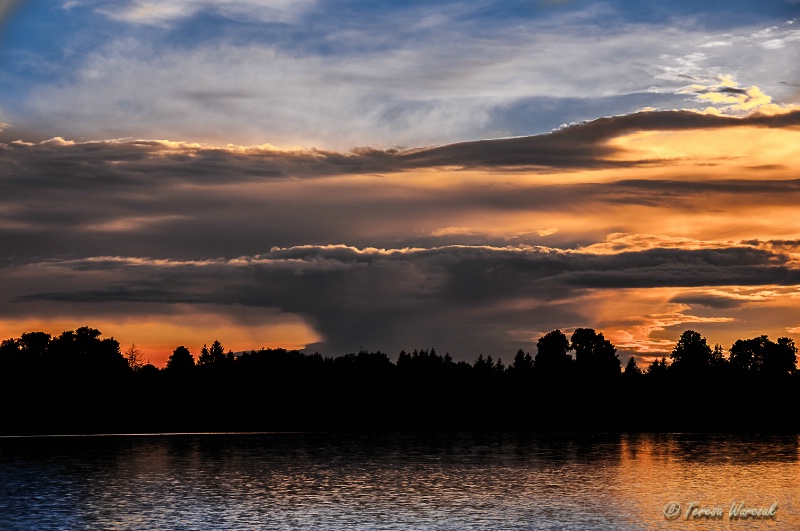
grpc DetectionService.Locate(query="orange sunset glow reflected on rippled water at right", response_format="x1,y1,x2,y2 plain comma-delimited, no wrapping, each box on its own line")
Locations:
617,434,800,530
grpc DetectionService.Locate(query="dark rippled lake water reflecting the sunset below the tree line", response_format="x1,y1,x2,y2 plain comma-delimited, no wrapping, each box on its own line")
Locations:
0,434,800,530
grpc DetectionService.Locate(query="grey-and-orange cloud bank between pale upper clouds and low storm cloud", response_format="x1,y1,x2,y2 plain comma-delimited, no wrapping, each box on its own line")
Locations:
0,107,800,266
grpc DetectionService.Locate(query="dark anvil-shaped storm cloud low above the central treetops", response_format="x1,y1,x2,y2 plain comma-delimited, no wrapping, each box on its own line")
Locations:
4,246,800,355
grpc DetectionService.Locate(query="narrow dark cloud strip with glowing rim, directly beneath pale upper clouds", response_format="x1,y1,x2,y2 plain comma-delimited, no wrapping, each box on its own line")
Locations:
0,111,800,183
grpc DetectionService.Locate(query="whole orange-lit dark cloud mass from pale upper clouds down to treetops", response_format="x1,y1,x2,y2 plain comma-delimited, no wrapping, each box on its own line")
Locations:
0,108,800,359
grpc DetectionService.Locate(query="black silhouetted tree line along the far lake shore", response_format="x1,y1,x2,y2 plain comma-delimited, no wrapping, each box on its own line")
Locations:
0,327,800,434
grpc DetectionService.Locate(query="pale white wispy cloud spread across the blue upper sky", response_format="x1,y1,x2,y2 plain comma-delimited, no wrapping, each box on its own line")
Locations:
8,6,796,150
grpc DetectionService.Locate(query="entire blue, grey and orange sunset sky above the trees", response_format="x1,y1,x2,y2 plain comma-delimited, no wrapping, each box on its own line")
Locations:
0,0,800,366
